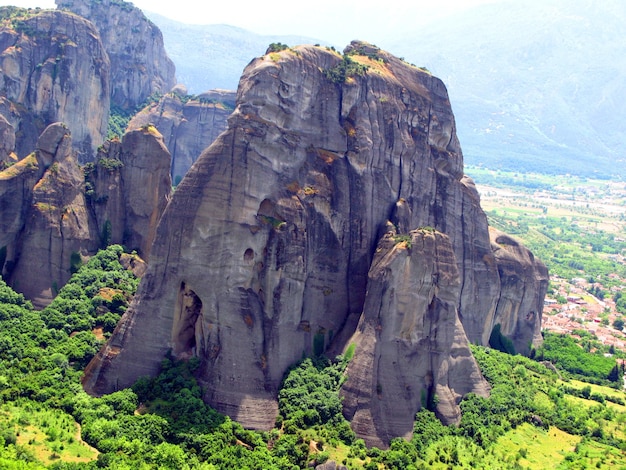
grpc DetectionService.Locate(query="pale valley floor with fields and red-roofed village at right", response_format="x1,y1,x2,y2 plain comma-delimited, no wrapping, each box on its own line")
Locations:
466,167,626,364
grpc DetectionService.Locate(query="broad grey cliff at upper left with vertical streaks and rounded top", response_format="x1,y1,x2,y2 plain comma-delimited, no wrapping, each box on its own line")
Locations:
0,9,109,161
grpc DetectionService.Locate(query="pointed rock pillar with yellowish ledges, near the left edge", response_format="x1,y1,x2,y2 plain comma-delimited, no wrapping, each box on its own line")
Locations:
3,123,98,307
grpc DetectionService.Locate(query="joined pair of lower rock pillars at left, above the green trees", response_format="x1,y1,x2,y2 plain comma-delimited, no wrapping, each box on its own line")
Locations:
0,123,171,307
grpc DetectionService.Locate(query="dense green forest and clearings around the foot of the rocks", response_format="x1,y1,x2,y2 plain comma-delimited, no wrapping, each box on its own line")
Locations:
0,246,626,470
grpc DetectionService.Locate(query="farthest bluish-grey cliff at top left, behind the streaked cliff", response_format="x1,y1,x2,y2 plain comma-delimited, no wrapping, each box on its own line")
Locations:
56,0,176,111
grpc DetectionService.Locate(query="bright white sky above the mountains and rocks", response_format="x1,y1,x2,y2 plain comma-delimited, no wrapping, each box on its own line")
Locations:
0,0,503,45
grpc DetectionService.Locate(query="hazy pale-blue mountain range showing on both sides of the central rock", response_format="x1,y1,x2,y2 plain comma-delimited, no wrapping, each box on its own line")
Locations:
147,0,626,177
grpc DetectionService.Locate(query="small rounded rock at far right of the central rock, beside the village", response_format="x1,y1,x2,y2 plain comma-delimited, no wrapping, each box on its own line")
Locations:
489,228,549,355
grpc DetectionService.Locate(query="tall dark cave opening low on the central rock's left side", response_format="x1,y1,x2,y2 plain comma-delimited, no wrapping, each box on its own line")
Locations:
172,282,202,359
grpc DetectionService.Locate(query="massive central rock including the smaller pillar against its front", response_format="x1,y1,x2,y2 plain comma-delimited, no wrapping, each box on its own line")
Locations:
84,42,544,443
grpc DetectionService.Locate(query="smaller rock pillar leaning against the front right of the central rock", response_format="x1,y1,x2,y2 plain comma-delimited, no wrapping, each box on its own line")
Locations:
342,230,489,448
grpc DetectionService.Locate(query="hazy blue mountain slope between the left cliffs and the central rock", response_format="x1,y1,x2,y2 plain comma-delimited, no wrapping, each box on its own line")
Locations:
145,11,324,94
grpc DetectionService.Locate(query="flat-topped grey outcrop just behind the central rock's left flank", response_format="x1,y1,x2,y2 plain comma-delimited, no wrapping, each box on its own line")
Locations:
128,86,235,183
